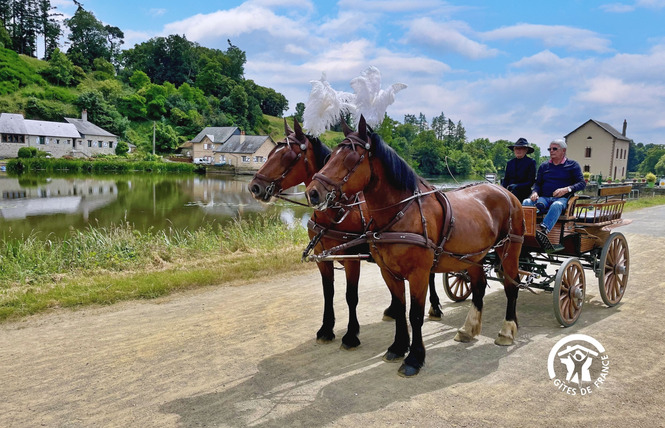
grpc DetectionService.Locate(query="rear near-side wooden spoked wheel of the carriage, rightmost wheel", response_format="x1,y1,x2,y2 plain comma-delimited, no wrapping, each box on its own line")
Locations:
598,232,630,307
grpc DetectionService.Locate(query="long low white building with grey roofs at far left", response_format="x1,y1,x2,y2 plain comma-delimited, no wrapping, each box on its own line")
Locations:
0,110,118,158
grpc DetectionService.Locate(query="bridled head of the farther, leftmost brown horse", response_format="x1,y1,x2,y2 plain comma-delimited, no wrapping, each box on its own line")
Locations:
249,119,318,202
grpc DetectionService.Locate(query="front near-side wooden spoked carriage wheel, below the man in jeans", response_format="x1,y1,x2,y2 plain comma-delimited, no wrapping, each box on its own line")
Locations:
552,257,586,327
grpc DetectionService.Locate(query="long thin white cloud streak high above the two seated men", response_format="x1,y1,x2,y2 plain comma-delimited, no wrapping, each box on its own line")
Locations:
482,24,611,53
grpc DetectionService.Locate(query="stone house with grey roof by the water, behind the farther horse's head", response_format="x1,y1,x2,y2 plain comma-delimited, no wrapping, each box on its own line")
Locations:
180,126,276,171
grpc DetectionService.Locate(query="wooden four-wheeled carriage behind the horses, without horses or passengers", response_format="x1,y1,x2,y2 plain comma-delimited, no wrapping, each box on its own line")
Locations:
444,186,632,327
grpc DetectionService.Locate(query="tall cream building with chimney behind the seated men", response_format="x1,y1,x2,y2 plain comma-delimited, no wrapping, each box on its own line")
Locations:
565,119,632,180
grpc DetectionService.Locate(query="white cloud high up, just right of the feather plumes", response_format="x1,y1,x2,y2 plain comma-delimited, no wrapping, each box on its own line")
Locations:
404,17,499,59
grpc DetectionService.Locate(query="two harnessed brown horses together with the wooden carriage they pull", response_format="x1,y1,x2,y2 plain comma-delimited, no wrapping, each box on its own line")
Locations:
250,116,629,376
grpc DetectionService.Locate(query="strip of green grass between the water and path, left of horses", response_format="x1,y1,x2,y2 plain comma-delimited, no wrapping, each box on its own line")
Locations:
0,216,314,321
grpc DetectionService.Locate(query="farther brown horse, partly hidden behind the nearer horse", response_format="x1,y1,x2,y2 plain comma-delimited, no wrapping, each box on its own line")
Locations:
249,120,441,349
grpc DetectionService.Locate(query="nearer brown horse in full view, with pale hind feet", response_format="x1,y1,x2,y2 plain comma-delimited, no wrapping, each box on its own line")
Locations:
306,117,525,376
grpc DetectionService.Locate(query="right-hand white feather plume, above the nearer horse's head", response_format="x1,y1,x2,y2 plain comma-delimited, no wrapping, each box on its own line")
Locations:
351,66,406,127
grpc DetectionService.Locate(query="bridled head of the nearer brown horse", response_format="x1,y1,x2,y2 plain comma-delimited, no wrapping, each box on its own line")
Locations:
305,116,372,211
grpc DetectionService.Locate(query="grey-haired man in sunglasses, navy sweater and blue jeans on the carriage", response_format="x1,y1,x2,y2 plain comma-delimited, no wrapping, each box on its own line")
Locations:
522,139,586,252
